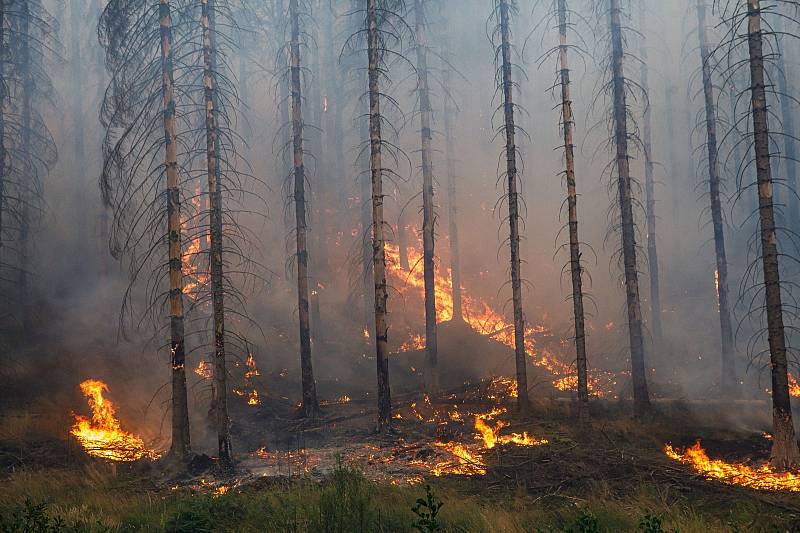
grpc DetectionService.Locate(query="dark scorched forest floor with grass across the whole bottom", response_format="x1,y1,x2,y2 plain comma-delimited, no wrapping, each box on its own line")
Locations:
0,392,800,532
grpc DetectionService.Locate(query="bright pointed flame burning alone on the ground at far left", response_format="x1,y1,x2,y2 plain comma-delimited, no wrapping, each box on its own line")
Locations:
71,379,159,461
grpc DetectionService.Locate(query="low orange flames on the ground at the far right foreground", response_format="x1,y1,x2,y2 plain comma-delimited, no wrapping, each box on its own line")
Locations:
664,441,800,492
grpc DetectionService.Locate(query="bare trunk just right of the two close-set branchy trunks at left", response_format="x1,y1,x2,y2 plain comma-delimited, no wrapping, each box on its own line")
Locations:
289,0,319,417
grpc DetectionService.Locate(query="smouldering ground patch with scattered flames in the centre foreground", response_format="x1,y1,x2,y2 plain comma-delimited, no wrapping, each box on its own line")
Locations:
234,377,548,484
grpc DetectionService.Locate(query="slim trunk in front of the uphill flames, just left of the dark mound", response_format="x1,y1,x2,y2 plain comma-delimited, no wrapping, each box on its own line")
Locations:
414,0,439,391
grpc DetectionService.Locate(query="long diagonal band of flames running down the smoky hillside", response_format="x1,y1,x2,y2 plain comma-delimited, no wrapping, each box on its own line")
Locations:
386,243,604,396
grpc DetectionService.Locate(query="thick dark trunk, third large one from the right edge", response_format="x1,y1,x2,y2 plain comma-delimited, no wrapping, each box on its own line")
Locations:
609,0,650,417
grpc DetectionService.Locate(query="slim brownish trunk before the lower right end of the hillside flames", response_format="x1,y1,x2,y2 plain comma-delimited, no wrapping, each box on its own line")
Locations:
558,0,589,417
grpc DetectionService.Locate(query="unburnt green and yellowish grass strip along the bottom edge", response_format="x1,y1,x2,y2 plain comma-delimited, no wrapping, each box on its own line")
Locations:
0,466,800,533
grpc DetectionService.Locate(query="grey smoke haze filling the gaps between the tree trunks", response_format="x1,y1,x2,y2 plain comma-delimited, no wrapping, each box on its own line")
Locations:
2,0,788,449
